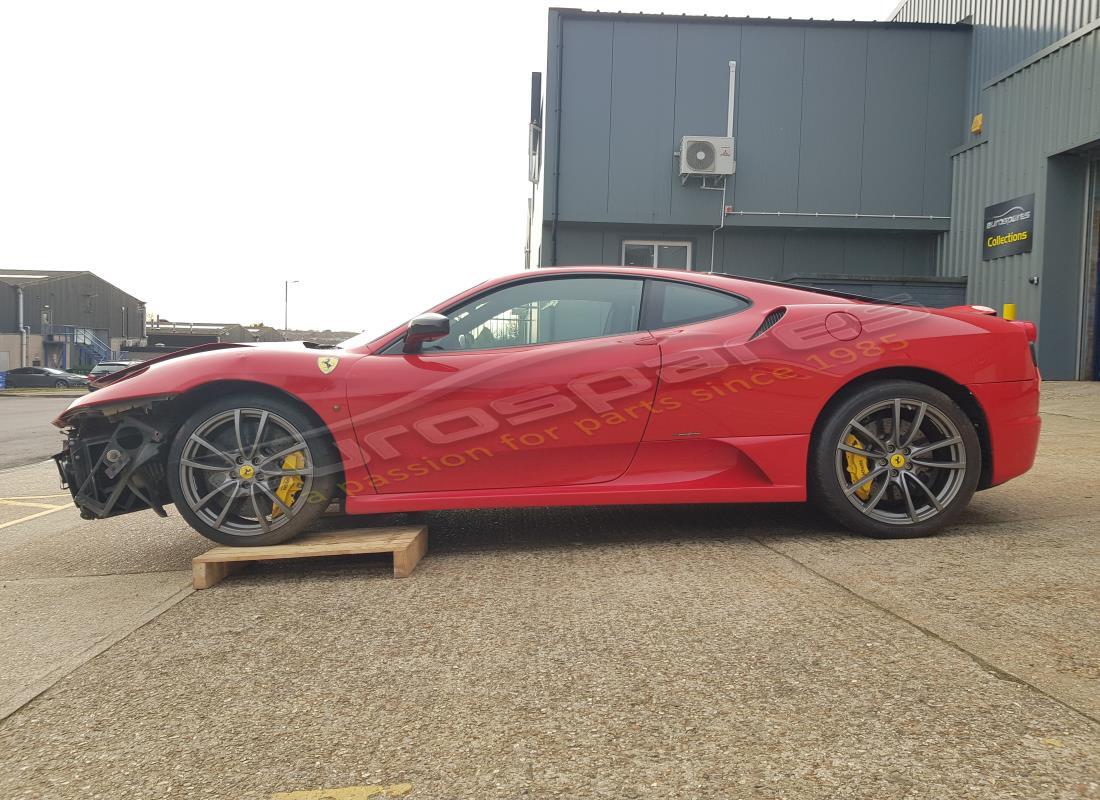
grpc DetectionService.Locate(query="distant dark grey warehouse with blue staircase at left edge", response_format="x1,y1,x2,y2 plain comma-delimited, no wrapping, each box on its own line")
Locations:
0,269,145,372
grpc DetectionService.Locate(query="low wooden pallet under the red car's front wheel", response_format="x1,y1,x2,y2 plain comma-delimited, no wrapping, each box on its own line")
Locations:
191,525,428,589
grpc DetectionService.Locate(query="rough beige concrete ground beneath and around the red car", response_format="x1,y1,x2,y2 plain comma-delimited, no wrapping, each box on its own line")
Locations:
0,384,1100,800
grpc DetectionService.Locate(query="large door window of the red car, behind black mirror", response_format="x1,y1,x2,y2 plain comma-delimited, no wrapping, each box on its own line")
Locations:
424,277,642,352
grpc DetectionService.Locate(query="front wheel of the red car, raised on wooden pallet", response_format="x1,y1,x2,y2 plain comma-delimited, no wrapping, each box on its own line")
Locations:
167,394,340,547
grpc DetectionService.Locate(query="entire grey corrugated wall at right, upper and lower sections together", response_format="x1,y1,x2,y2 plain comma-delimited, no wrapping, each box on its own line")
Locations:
893,0,1100,379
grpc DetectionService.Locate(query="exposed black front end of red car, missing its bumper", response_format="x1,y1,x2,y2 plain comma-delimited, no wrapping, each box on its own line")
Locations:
54,401,172,519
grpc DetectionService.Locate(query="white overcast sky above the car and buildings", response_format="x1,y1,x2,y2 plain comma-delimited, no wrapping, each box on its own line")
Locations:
0,0,893,332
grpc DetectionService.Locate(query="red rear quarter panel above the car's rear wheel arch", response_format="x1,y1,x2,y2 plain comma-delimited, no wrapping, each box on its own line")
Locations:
646,304,1035,441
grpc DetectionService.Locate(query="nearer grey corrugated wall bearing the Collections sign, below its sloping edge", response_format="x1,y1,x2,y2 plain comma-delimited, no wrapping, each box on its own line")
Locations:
937,29,1100,377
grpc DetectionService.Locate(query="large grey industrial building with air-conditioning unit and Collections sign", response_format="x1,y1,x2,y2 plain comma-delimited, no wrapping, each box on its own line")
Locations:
532,0,1100,379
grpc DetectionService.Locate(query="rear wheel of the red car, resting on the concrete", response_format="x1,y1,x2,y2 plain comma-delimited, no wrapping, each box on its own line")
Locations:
810,381,981,539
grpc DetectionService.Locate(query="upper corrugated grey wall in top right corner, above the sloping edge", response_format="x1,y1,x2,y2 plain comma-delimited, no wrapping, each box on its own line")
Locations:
893,0,1100,118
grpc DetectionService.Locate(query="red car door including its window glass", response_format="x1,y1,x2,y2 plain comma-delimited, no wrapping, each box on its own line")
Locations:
348,275,659,494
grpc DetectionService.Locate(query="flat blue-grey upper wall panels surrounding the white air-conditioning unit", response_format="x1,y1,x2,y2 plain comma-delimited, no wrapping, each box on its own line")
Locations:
543,12,969,224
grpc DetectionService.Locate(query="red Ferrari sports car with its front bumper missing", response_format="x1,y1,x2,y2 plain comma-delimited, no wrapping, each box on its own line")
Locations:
55,267,1040,545
